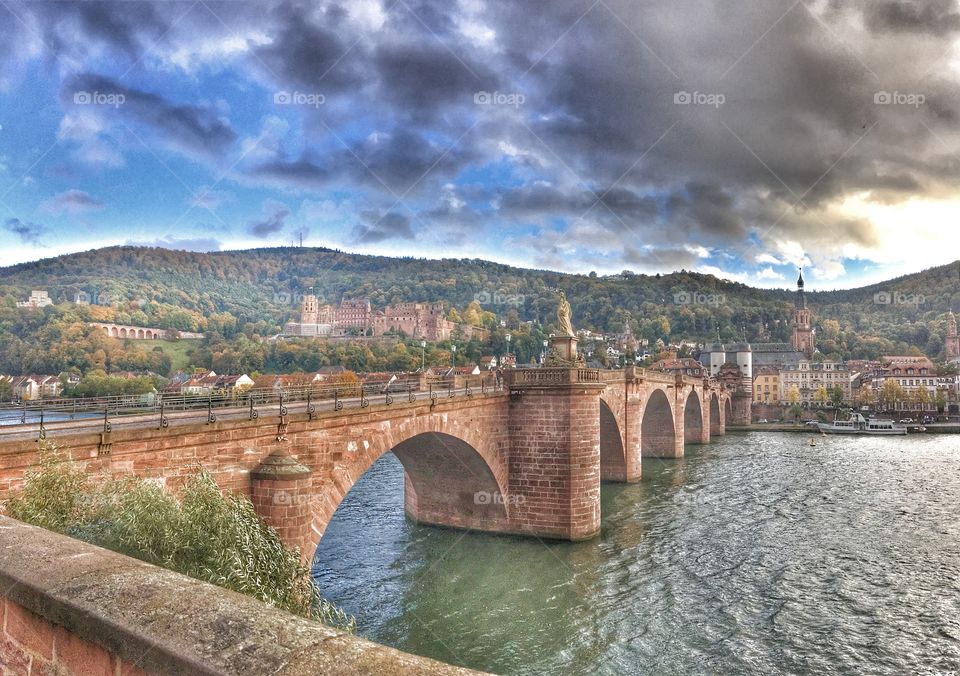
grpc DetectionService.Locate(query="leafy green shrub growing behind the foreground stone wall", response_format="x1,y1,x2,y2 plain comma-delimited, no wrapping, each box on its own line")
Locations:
7,442,356,632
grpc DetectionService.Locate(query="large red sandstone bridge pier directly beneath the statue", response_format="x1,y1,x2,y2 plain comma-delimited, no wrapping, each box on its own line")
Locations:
507,368,604,540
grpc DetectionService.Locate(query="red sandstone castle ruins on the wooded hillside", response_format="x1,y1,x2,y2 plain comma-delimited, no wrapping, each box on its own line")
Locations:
284,295,484,342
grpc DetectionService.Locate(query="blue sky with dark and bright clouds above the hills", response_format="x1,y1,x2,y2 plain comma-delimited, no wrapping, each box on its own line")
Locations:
0,0,960,288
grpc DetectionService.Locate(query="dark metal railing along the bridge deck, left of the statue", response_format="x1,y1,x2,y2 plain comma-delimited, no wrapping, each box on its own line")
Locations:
0,374,503,430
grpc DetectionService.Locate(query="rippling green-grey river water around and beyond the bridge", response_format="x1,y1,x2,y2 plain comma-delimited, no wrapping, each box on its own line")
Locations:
314,432,960,674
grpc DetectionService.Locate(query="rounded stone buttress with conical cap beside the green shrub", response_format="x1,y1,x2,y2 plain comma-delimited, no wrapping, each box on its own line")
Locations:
250,451,313,563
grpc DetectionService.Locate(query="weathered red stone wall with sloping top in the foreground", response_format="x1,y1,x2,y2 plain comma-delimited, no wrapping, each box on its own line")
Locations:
0,517,475,676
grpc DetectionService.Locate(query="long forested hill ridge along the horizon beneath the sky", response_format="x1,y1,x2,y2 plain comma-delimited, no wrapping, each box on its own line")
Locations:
0,247,960,356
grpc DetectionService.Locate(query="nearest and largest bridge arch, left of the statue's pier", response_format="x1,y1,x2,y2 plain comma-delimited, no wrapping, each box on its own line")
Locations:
304,414,515,558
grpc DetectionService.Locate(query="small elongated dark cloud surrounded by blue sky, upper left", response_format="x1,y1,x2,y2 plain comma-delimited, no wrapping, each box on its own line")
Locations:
61,73,237,159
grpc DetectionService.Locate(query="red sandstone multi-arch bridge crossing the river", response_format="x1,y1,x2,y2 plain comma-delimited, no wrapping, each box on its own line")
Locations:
0,368,733,557
